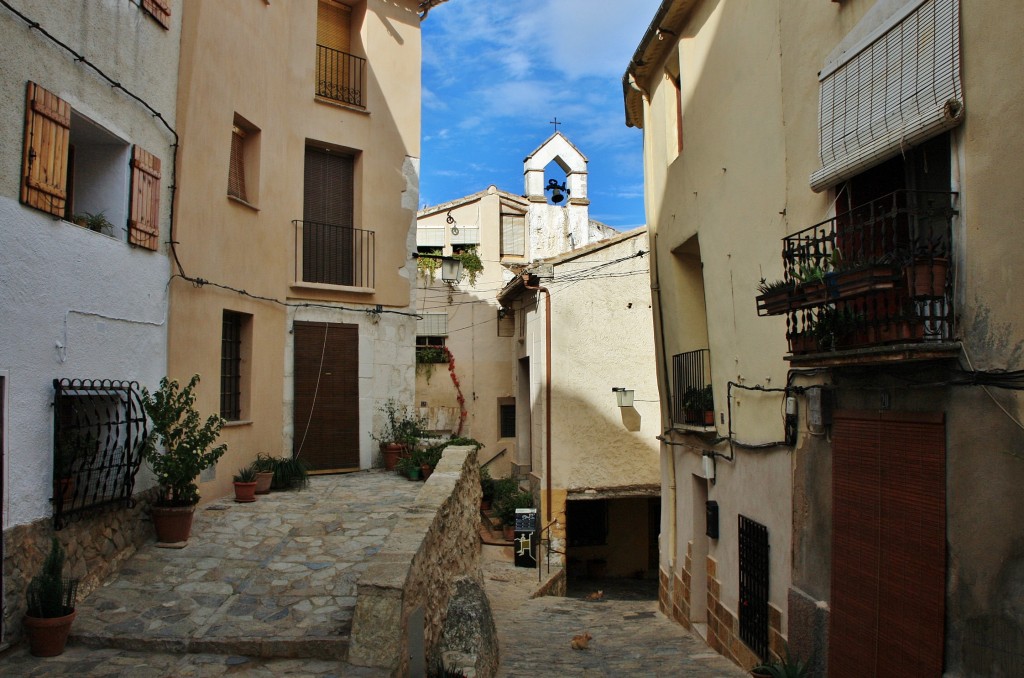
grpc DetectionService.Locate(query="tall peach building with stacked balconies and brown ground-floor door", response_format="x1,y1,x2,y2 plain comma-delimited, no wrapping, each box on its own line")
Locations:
168,0,420,497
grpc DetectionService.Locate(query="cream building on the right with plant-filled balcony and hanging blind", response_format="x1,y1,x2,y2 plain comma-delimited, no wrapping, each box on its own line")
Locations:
624,0,1024,676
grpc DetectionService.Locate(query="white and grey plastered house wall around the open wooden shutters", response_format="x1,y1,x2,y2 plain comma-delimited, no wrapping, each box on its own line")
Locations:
0,0,181,527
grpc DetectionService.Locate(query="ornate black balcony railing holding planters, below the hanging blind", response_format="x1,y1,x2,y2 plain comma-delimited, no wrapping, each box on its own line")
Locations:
758,190,957,354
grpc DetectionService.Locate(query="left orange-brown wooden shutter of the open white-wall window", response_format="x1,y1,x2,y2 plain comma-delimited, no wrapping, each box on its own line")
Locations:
22,82,71,217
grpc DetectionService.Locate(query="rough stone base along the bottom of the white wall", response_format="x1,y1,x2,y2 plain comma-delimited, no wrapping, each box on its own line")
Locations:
0,489,157,645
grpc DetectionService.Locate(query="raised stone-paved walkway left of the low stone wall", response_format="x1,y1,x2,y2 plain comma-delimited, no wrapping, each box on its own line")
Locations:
0,471,423,676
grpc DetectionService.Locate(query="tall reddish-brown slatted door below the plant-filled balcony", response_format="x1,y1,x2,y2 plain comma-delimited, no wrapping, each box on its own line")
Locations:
828,412,946,678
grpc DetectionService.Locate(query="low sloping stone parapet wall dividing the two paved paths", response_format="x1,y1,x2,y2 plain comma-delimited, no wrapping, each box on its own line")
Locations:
348,447,483,675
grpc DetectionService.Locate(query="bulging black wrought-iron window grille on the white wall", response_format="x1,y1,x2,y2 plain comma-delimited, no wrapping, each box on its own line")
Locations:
52,379,148,529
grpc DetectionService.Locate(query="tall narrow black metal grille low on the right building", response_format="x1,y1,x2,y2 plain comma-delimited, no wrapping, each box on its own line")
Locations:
739,515,769,660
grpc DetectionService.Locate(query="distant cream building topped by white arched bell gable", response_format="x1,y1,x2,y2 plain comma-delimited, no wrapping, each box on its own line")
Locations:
416,132,615,477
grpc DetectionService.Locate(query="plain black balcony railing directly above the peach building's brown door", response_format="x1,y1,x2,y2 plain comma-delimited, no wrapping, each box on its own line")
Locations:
292,220,374,288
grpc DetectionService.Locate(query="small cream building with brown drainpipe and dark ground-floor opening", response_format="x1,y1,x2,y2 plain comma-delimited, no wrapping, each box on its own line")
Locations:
499,229,660,579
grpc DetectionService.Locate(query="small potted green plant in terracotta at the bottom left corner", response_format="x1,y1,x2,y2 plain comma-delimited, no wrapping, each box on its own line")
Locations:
24,537,78,656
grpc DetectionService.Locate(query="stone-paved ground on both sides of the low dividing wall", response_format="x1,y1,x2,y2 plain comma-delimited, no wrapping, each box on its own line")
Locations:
0,471,745,678
